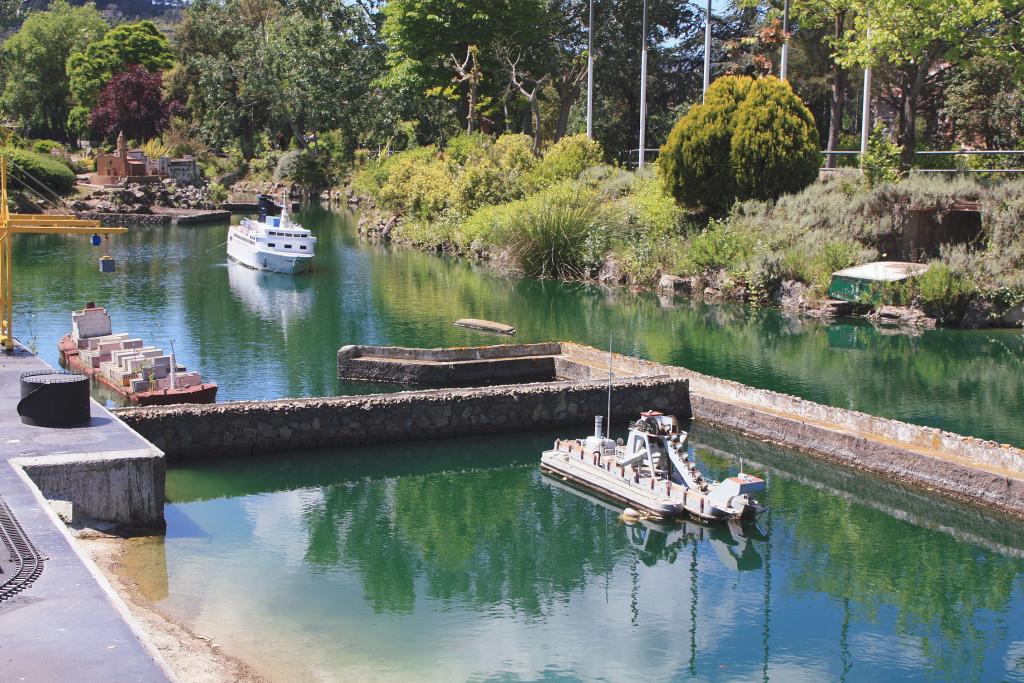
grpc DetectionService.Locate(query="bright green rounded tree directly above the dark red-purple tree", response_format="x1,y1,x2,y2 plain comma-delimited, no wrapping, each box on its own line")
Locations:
68,22,174,121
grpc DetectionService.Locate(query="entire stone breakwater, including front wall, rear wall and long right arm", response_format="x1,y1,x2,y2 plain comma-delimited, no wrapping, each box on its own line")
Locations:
112,342,1024,518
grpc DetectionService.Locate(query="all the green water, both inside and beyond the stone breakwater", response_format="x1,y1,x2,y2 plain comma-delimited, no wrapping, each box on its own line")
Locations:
14,208,1024,681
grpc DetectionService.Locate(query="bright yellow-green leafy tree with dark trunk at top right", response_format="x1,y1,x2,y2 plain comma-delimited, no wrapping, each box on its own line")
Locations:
838,0,1024,166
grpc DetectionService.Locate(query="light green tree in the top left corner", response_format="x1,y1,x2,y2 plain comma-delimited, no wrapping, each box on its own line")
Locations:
0,0,108,140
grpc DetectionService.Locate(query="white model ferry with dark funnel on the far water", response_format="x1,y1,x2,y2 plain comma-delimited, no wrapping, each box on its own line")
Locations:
227,195,316,273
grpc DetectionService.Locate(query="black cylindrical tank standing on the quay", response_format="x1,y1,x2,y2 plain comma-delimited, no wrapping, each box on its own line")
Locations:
17,370,89,427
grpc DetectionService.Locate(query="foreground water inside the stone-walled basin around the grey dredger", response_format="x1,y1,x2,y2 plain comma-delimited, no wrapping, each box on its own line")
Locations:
129,427,1024,681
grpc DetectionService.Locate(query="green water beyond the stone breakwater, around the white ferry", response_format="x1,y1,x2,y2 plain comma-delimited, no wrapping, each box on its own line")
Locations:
14,202,1024,445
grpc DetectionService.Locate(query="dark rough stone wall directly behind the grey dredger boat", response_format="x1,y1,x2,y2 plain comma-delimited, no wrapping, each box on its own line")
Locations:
117,377,689,460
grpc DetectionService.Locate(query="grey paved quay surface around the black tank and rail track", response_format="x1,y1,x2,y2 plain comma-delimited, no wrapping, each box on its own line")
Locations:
0,349,169,683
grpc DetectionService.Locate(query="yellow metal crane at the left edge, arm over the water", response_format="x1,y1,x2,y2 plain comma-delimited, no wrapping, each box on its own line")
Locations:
0,157,128,351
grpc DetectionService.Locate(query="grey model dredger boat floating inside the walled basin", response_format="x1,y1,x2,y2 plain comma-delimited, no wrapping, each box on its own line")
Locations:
541,411,765,522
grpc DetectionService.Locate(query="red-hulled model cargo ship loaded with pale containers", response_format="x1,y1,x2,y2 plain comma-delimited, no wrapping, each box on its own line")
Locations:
58,303,217,405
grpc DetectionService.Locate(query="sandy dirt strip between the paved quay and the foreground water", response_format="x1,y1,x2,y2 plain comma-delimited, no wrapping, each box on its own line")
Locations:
72,529,267,683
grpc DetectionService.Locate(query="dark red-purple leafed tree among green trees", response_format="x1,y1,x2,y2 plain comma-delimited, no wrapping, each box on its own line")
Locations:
89,65,174,140
